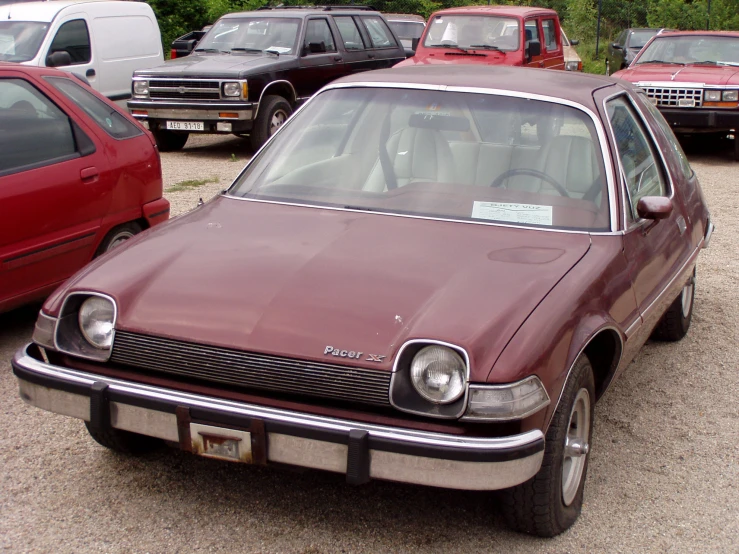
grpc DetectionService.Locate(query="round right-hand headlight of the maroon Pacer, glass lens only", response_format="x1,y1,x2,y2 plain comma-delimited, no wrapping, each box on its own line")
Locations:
411,345,466,404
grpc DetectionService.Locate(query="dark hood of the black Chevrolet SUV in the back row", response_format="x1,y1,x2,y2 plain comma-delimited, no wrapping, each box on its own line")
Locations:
135,54,292,78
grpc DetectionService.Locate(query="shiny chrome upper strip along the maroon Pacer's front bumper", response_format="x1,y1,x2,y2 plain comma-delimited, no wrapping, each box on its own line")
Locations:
14,349,544,451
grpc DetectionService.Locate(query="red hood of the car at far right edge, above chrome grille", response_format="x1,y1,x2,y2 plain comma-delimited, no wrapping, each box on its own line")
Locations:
613,63,739,85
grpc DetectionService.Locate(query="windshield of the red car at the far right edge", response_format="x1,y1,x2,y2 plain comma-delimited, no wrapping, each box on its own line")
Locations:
638,35,739,66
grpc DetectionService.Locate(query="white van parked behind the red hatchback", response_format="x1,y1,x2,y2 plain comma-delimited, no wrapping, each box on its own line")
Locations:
0,0,164,105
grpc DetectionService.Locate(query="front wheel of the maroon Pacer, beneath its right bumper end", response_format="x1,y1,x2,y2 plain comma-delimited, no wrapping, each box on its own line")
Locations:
501,356,595,537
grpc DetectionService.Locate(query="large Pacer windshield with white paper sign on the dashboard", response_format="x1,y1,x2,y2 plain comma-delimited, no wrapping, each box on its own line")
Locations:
228,87,609,230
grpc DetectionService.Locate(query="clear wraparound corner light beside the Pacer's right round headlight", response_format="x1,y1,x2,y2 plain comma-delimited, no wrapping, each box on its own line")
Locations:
464,375,549,421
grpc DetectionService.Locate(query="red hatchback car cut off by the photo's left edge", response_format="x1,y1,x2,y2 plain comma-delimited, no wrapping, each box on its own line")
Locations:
0,63,169,312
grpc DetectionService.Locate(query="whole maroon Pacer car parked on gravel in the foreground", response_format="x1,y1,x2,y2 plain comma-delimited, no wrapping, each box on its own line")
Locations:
13,66,713,536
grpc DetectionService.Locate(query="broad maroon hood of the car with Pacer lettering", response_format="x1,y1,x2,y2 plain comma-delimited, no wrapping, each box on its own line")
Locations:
56,197,590,380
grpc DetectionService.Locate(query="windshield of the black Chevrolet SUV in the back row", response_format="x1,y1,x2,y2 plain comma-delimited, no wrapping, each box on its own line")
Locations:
195,17,300,54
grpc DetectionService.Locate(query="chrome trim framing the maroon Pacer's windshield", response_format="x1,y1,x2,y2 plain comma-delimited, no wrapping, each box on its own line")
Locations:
224,82,620,235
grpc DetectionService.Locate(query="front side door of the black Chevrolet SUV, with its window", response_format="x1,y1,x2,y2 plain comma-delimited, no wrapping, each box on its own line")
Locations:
293,17,346,98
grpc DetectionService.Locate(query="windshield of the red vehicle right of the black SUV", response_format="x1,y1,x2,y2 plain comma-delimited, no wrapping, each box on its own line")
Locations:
423,15,521,52
